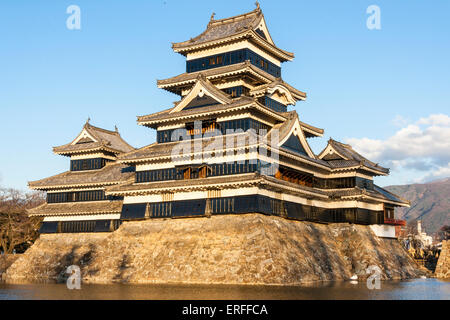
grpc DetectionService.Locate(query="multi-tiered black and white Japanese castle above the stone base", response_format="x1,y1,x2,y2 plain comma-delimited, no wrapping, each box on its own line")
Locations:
29,4,409,237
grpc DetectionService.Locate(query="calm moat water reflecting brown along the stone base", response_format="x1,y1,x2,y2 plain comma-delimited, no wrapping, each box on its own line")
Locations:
0,279,450,300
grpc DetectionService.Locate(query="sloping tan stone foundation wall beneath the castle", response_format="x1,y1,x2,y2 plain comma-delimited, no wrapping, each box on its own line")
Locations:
7,214,424,285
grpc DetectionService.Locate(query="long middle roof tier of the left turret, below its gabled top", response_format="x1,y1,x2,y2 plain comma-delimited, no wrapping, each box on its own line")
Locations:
28,163,134,190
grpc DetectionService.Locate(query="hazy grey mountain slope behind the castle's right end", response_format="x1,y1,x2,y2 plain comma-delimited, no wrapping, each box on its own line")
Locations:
385,178,450,235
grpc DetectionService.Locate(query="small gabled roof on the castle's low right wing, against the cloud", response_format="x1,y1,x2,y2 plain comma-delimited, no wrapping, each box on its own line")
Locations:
318,138,389,175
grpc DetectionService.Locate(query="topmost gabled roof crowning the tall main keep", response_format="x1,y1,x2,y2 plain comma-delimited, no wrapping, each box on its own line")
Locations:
172,4,294,61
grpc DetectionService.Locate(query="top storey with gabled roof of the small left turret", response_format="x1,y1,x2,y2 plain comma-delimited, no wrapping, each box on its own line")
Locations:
53,120,134,171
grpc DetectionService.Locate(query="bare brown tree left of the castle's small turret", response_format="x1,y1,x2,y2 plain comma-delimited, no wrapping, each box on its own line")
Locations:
0,189,44,254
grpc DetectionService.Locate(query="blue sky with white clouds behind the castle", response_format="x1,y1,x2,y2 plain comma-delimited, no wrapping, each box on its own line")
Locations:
0,0,450,189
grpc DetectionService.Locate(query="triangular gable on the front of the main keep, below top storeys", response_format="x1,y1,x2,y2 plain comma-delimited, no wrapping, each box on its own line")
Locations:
169,74,232,113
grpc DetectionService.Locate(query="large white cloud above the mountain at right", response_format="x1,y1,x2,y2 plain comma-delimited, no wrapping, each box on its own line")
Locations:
346,114,450,179
